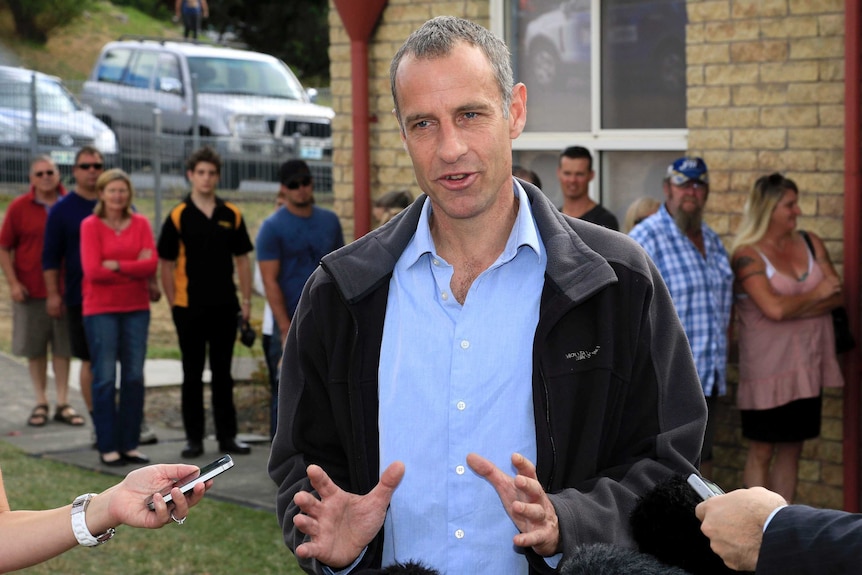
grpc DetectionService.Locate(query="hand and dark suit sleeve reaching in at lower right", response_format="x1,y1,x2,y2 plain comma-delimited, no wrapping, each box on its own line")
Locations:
695,487,862,575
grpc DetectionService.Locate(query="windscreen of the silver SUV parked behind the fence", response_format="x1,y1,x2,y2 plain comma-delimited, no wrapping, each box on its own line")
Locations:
188,57,304,100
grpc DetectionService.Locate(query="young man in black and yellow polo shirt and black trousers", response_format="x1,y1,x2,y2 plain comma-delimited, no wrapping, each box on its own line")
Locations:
158,147,253,458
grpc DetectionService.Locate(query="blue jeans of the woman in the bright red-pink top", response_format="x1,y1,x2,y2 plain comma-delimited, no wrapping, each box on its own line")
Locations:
84,310,150,453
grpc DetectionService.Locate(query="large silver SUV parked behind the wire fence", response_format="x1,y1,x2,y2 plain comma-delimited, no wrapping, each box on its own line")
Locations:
81,37,335,191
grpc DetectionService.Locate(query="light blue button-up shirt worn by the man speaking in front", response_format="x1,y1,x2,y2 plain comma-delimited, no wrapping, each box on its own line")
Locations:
379,183,547,575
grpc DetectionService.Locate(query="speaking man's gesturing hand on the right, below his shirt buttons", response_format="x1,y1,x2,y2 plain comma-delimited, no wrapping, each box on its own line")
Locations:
467,453,560,557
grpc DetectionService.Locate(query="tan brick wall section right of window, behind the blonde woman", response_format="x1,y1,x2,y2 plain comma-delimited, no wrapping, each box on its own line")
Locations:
686,0,844,508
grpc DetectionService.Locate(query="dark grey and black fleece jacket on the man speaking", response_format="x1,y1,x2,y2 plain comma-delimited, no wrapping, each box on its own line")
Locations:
269,182,706,573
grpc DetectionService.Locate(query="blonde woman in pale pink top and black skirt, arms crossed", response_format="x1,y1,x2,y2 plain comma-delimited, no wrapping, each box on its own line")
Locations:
731,174,843,501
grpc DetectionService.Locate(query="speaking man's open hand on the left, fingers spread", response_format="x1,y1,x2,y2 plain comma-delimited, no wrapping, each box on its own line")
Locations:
293,461,404,570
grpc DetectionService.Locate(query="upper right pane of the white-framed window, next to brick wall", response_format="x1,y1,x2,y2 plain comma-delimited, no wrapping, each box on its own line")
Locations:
601,0,686,129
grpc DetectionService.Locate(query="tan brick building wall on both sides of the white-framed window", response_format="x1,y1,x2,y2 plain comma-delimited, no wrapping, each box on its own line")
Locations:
329,0,844,508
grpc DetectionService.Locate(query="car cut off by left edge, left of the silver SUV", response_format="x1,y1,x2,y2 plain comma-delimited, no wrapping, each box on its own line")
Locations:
0,66,117,182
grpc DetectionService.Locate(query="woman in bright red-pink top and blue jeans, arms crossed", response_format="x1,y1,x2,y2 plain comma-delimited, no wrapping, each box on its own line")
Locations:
81,169,158,466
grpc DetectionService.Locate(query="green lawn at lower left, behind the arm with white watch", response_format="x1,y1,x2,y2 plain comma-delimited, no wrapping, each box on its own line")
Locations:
0,441,302,575
